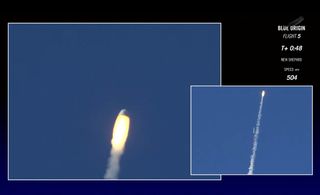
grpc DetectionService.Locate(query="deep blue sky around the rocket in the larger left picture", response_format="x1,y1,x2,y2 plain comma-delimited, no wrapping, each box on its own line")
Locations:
9,24,220,179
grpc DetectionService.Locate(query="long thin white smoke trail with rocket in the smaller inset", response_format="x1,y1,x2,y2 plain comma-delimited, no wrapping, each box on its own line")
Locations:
248,90,265,175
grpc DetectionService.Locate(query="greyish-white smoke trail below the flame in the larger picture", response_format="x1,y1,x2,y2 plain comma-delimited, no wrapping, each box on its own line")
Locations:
104,148,123,179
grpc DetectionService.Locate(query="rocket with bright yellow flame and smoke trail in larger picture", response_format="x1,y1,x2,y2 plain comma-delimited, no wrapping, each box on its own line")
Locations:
104,109,130,179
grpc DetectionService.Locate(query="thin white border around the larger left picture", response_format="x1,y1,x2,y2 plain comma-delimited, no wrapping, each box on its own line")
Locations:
7,22,222,181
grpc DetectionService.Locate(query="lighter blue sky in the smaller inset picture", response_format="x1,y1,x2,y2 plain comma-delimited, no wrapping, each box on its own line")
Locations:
192,87,312,174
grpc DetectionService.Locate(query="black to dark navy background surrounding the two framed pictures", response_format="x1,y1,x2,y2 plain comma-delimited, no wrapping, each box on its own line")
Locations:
0,12,320,194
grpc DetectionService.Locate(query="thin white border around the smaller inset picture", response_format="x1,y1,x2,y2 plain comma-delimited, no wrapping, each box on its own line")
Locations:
190,85,314,177
